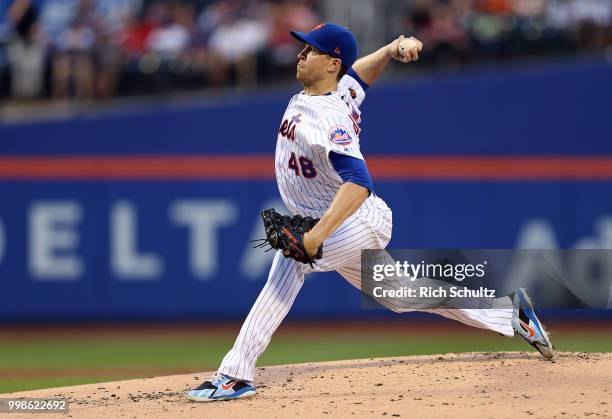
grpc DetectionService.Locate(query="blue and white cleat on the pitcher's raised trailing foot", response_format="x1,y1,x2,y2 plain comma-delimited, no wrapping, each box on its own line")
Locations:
512,288,554,359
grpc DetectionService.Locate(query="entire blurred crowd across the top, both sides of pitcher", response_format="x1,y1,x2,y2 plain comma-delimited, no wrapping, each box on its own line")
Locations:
0,0,612,100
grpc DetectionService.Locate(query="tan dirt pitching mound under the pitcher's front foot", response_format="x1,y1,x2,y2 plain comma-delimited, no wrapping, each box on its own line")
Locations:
2,352,612,419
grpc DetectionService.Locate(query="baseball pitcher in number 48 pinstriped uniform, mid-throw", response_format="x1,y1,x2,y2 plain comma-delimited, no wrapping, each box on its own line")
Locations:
187,23,553,401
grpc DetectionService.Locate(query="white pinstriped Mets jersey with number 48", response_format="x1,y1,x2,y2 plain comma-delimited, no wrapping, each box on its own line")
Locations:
275,75,386,218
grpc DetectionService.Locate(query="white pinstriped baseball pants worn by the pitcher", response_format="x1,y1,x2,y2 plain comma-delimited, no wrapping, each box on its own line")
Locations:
219,208,514,381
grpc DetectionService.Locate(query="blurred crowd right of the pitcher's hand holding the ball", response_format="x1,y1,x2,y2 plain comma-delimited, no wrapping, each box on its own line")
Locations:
393,0,612,68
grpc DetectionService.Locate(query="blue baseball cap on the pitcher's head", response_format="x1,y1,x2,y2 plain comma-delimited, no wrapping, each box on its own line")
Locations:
289,23,357,68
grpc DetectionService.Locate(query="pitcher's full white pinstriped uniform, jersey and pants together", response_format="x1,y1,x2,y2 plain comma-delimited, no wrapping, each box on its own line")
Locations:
218,75,514,381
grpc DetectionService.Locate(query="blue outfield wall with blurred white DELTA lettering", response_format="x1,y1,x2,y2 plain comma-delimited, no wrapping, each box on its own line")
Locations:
0,63,612,322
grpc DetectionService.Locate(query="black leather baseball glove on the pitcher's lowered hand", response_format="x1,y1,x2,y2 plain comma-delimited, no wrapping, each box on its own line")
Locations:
256,208,323,266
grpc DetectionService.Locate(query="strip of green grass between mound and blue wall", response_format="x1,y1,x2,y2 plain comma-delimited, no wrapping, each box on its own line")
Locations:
0,328,612,393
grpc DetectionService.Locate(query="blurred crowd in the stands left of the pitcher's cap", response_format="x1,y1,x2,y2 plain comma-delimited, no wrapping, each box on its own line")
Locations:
0,0,320,99
